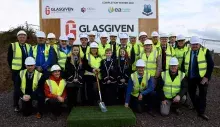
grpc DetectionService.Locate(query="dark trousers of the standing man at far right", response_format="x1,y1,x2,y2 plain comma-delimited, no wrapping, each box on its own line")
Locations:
188,78,208,114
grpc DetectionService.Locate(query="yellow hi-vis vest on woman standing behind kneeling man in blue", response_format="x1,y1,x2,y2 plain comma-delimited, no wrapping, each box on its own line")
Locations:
140,49,158,76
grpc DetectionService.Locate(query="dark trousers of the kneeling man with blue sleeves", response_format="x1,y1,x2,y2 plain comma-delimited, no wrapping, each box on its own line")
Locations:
129,93,153,113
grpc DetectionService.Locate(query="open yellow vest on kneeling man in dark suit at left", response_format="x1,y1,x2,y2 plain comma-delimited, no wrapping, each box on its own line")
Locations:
19,69,42,94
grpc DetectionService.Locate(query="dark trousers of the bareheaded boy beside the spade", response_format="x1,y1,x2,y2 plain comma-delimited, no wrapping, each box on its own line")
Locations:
102,83,117,106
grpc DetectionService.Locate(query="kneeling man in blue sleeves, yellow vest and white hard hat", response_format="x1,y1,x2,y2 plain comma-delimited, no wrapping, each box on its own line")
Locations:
125,59,155,116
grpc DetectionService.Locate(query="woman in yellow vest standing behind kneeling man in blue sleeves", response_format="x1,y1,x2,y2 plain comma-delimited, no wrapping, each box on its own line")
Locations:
140,40,162,85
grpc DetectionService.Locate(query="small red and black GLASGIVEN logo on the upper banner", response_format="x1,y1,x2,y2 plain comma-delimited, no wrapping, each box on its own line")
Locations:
45,6,74,15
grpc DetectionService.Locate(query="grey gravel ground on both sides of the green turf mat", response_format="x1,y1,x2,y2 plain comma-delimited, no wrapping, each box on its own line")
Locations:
0,77,220,127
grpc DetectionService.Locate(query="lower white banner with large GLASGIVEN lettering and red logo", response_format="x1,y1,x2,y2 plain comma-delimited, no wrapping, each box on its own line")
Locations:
60,18,138,44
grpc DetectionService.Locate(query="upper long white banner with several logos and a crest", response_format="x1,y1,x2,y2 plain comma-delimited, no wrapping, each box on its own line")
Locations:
42,0,156,19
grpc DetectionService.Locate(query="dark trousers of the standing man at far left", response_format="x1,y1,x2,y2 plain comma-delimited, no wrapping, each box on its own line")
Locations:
12,70,20,107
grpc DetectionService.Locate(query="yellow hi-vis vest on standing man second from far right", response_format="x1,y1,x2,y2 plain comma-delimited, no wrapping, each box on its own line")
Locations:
175,46,189,69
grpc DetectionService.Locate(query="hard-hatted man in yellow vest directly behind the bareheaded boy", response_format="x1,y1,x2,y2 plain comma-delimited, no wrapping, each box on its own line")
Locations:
98,32,111,59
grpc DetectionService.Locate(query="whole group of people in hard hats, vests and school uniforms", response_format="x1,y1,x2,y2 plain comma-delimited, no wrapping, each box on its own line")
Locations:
8,30,214,120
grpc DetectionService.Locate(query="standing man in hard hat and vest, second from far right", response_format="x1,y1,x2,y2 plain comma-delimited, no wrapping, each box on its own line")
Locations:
174,34,189,70
